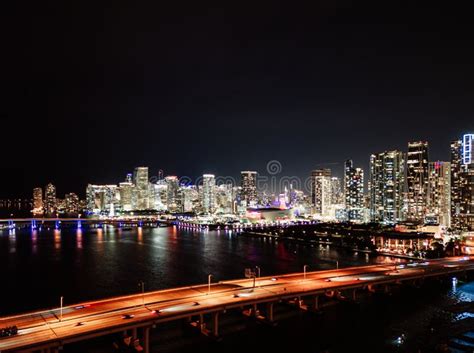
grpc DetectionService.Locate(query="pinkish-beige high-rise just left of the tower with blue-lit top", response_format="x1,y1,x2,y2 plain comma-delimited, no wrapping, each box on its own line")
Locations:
427,161,451,227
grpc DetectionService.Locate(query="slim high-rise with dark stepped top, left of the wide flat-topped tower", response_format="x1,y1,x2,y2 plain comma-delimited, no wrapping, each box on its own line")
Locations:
344,159,365,222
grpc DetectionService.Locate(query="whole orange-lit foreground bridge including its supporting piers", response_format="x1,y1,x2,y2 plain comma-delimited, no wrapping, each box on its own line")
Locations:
0,257,474,353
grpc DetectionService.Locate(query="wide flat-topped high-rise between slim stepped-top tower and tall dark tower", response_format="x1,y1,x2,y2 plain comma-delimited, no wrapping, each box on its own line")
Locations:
369,151,405,223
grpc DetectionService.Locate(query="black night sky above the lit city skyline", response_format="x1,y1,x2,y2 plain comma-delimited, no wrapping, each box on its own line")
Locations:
0,0,474,197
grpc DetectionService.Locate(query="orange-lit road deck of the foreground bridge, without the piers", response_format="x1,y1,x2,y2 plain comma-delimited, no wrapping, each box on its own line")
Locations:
0,257,474,352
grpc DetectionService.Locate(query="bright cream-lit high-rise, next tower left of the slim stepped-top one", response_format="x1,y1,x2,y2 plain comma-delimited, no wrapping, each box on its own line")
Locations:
311,169,332,217
